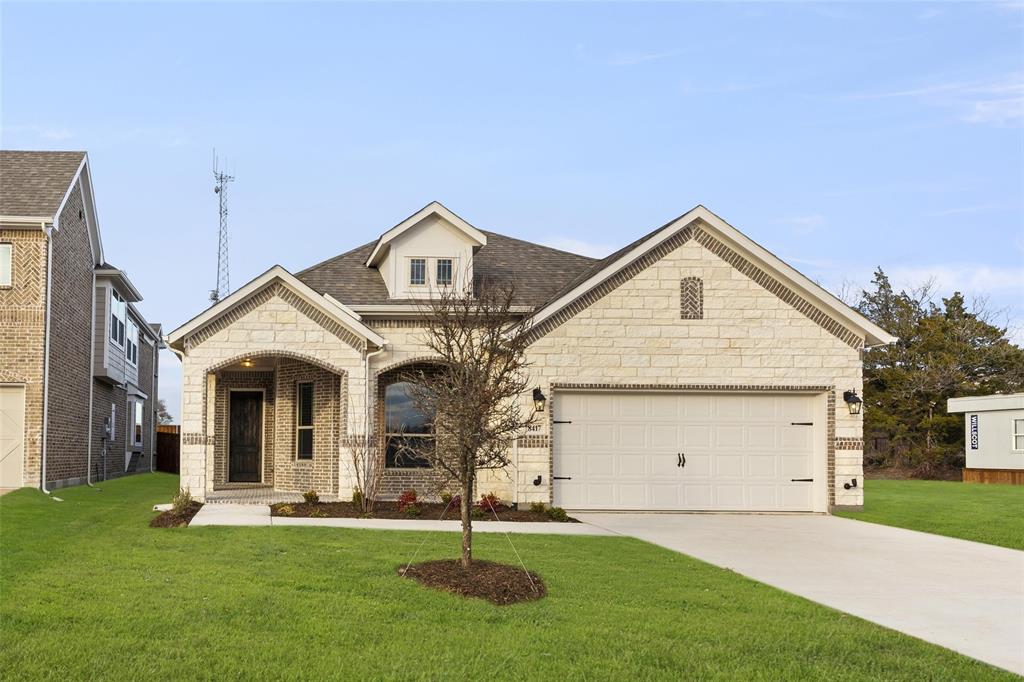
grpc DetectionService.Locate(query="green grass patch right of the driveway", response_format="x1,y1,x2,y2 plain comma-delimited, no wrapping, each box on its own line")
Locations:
838,480,1024,550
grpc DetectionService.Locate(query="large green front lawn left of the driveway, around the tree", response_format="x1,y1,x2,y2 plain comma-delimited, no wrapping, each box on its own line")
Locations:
0,474,1014,680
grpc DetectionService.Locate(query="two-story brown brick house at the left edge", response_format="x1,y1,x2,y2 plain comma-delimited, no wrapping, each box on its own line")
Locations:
0,151,162,489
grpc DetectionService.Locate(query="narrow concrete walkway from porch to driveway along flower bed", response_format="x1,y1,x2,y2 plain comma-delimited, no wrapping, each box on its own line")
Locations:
188,504,615,536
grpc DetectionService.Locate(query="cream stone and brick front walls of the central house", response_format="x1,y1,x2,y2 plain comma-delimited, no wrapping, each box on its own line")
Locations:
182,220,863,506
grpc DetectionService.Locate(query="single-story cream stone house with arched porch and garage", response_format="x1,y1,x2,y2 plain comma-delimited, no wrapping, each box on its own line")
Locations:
167,203,893,512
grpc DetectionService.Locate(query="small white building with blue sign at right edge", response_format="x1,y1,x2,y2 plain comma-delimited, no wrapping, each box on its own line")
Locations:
946,393,1024,484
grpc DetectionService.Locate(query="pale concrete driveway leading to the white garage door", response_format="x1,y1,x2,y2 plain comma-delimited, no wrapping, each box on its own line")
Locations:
573,513,1024,674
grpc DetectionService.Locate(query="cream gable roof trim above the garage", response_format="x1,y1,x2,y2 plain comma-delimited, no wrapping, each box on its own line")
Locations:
531,206,896,346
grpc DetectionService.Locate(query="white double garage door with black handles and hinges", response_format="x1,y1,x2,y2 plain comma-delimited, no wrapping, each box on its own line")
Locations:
553,392,825,511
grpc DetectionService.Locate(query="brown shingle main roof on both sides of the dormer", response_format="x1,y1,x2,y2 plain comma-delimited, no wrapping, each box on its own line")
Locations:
295,230,595,307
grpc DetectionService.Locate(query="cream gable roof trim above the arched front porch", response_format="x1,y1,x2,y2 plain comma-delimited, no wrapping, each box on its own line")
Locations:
167,265,387,349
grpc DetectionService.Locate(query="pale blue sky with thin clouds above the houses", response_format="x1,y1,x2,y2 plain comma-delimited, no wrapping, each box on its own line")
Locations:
0,2,1024,414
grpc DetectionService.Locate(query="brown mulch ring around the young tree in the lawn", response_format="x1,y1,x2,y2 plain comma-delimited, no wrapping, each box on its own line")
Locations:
398,559,548,606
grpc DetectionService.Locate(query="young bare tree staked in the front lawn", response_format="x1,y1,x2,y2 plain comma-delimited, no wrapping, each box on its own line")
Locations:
397,283,534,567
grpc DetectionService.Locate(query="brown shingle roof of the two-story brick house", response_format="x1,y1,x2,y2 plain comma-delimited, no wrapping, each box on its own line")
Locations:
0,150,85,217
